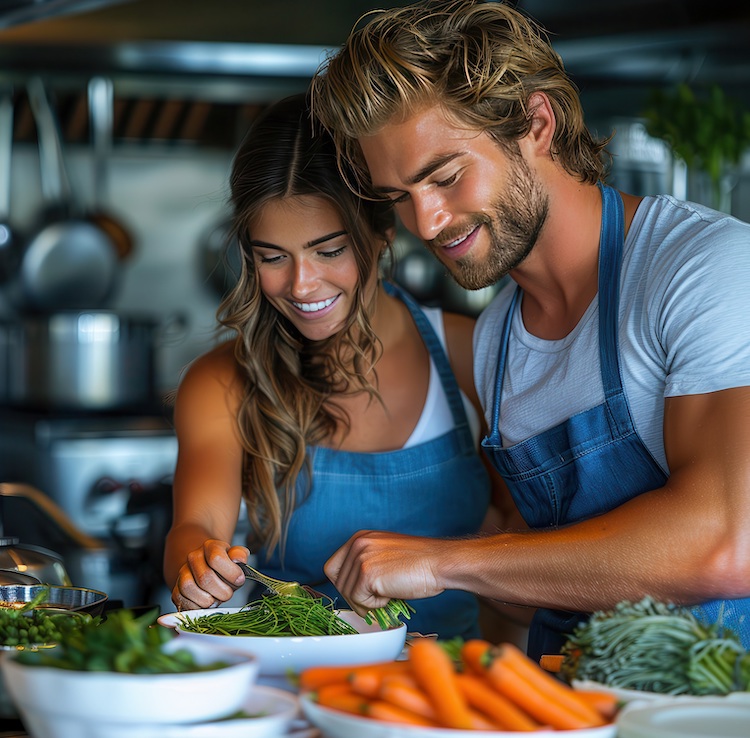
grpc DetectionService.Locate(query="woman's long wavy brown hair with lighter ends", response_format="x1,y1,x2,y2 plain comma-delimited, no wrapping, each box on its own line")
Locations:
218,95,394,555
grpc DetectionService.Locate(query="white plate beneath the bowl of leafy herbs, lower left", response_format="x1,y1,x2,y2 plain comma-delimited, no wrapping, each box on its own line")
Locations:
100,685,299,738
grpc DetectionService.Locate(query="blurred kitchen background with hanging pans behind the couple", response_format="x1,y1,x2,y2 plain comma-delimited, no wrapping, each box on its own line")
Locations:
0,0,750,607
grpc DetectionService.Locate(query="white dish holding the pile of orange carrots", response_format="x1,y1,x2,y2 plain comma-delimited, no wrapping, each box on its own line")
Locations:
299,695,620,738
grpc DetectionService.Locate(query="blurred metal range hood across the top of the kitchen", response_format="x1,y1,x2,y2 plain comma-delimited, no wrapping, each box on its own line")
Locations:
0,0,750,149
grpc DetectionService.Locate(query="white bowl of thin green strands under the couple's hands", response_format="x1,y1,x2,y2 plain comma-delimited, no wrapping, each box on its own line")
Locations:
158,607,406,676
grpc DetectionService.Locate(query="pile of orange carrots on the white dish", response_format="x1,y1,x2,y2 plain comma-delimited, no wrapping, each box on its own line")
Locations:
299,638,618,732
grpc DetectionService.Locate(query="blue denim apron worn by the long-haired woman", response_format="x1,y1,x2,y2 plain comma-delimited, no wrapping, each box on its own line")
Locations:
254,284,490,638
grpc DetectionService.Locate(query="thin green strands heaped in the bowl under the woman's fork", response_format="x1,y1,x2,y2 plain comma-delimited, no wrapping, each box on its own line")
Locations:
180,593,357,636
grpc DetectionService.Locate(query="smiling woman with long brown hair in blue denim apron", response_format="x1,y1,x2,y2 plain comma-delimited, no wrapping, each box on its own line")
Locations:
165,96,506,638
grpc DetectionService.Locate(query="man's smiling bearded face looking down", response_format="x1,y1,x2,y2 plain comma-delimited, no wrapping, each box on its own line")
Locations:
359,106,548,289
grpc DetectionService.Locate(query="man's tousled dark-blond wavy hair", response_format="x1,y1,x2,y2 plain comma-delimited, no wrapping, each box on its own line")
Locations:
311,0,608,193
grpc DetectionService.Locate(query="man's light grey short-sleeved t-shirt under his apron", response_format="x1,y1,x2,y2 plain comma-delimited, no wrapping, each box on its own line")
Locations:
474,195,750,473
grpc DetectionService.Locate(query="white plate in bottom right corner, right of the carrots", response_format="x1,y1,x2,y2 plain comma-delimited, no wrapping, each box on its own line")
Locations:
617,697,750,738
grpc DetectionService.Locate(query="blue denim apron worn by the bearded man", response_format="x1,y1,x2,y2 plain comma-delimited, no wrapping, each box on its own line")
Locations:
482,184,750,659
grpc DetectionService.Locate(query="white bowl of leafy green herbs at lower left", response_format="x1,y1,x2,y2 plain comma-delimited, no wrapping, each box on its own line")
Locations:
2,638,258,738
